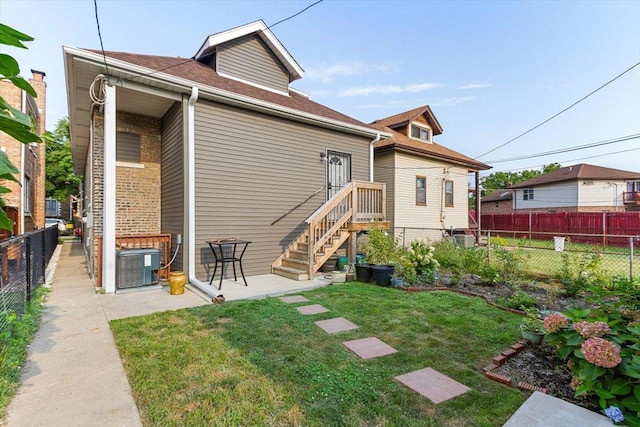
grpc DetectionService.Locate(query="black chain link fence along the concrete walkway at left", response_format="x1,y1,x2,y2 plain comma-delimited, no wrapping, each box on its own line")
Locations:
0,227,58,331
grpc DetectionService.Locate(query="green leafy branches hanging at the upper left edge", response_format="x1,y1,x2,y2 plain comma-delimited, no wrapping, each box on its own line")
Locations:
0,24,42,230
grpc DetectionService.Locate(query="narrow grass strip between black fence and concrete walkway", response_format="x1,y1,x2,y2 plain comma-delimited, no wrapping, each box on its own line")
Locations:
0,287,48,419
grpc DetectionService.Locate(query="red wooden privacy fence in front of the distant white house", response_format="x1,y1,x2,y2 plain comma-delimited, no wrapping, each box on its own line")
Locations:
481,212,640,246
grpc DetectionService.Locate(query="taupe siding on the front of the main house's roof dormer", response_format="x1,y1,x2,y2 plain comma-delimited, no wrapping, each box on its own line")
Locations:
216,35,289,93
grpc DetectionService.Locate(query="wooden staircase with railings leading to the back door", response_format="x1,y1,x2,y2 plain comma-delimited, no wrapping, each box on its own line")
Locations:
271,181,389,280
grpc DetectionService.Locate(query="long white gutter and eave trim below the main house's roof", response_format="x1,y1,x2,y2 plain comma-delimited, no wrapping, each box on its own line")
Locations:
63,46,391,138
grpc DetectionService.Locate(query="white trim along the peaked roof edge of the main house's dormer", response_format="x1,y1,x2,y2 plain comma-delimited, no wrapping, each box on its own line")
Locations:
194,19,304,80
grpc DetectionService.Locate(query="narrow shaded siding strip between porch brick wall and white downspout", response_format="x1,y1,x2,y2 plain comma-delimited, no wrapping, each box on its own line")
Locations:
161,102,186,271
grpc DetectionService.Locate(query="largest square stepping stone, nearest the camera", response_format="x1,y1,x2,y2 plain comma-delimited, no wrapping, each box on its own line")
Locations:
395,368,471,403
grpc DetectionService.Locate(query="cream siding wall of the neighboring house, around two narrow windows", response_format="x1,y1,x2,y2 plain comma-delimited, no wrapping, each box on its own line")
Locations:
387,153,469,234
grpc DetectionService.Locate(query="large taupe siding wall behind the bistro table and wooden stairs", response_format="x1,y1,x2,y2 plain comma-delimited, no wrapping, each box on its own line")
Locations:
195,101,368,285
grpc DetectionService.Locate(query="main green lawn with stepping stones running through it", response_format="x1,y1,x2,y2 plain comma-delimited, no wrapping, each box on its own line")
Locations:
112,283,526,426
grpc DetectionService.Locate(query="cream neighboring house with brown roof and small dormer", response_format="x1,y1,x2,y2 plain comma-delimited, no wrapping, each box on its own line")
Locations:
370,106,490,241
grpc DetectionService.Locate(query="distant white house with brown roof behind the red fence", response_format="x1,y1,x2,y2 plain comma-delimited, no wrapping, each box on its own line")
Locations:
504,164,640,214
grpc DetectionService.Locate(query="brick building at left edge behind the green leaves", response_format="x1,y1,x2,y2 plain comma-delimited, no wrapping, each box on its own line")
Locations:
0,70,47,239
